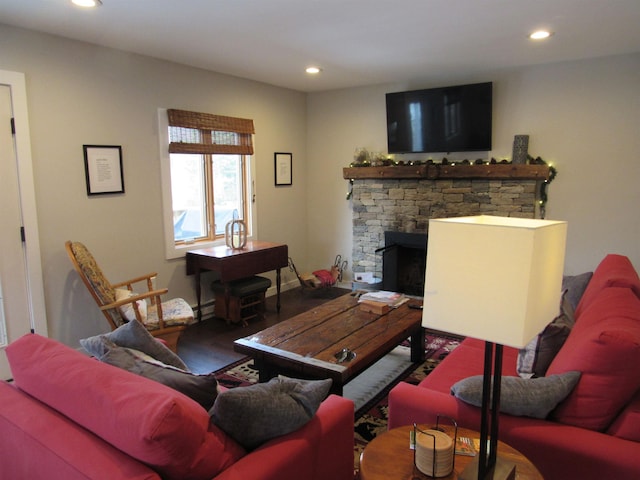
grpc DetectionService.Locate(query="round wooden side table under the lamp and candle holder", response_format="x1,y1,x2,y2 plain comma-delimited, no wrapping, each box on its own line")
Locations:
360,425,543,480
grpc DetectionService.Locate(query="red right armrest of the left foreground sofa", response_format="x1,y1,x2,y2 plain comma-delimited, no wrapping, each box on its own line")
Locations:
215,395,354,480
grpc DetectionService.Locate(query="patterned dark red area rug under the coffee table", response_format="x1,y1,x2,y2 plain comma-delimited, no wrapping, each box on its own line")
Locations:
216,333,460,470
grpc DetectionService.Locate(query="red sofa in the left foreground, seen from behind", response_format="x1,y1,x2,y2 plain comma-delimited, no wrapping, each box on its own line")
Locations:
0,334,353,480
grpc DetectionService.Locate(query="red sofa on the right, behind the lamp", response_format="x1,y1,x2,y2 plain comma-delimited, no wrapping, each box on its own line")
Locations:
388,255,640,480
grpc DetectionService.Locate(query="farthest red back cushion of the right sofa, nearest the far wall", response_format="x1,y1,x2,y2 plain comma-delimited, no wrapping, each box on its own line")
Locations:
575,254,640,321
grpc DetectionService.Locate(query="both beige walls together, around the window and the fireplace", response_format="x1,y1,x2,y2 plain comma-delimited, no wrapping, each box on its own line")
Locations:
0,21,640,345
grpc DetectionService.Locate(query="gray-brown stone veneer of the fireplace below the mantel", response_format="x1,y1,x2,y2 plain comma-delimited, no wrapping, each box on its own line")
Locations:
351,178,541,278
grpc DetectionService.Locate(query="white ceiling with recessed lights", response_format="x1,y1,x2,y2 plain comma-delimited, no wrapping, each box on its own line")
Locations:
0,0,640,92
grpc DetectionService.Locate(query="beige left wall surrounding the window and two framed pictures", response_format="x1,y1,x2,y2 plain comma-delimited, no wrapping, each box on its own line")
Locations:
0,25,307,346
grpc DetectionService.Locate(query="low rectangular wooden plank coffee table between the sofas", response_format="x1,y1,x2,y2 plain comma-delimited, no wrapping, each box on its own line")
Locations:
234,295,424,395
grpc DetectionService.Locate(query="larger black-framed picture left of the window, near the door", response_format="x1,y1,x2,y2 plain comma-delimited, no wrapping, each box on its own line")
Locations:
82,145,124,195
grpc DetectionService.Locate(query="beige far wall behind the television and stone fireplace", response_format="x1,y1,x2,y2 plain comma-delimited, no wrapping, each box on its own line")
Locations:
308,54,640,274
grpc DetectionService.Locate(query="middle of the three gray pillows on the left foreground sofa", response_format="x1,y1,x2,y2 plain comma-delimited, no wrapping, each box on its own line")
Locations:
100,346,218,410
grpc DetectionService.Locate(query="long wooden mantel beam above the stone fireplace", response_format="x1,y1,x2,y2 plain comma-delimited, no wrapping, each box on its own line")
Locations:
342,163,549,180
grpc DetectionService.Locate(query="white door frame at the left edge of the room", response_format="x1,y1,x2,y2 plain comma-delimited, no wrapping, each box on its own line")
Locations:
0,70,48,342
